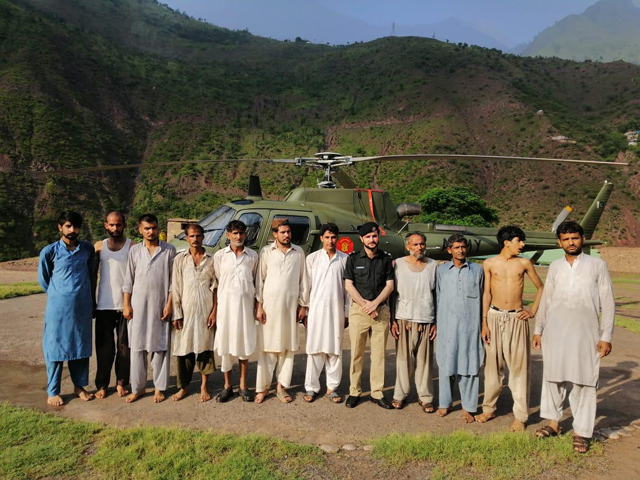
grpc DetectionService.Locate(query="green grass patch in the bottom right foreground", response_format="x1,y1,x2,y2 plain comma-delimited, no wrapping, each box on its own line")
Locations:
373,431,602,479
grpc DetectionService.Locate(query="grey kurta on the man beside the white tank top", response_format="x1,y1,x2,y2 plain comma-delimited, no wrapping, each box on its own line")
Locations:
122,242,176,352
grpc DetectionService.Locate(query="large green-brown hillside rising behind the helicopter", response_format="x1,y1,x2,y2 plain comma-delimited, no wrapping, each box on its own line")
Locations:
0,0,640,259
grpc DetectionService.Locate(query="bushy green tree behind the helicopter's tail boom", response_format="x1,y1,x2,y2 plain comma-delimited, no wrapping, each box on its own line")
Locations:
418,187,499,227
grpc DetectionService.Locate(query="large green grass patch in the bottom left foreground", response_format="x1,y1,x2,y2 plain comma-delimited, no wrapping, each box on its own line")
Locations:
0,404,323,479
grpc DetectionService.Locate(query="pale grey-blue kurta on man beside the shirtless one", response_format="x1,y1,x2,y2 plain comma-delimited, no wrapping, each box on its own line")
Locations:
436,262,484,376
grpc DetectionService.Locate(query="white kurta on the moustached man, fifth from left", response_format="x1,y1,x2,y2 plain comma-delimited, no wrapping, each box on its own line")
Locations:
213,247,258,357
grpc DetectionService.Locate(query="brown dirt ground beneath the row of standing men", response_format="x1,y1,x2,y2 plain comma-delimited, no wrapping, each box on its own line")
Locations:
0,261,640,478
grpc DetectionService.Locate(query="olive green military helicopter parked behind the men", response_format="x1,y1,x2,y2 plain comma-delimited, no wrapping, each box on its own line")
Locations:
26,152,628,262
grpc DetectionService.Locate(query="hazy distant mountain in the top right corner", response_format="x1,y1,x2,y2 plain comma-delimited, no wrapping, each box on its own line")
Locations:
521,0,640,64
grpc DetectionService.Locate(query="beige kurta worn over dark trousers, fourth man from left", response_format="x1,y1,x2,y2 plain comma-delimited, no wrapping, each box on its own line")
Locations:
171,250,214,357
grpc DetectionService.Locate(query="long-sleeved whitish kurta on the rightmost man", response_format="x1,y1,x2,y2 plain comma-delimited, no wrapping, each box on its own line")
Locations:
535,253,615,386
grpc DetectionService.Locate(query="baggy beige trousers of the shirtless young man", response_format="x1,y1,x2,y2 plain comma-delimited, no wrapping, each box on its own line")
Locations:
482,309,531,422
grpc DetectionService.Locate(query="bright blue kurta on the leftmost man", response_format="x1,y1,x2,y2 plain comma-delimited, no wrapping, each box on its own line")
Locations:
38,239,95,362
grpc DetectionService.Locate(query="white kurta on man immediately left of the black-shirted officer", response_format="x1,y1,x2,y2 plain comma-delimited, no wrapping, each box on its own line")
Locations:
307,250,349,355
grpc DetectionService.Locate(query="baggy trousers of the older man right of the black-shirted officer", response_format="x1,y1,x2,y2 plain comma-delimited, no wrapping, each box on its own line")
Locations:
393,319,433,403
